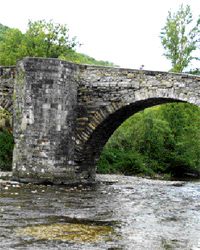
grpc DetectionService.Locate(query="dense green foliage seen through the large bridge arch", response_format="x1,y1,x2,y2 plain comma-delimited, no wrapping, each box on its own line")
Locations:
98,103,200,177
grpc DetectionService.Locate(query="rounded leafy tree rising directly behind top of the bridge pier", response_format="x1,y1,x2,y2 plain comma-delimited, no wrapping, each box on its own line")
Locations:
24,20,78,58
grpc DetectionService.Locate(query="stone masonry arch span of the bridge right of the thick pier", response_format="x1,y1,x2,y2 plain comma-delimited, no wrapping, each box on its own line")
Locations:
75,66,200,176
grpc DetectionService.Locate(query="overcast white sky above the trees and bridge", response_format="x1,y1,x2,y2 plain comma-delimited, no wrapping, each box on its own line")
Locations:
0,0,200,71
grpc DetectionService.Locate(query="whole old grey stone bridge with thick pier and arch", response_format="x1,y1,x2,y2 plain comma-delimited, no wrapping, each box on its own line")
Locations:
0,58,200,184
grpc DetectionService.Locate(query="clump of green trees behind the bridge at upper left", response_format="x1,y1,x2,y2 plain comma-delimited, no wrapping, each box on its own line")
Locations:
0,20,78,66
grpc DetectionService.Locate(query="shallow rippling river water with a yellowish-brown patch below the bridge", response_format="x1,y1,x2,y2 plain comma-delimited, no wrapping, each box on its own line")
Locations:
0,175,200,250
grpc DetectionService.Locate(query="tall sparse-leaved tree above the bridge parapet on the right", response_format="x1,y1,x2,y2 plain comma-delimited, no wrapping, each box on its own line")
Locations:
160,5,200,72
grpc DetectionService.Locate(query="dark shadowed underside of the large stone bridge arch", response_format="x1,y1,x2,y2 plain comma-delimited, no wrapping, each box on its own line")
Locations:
76,98,186,177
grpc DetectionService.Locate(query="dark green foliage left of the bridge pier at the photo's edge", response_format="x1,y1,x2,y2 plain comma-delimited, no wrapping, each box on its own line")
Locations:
0,129,14,171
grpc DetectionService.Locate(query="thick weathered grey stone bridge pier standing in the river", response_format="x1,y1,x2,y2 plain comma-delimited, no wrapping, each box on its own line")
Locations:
13,58,93,184
